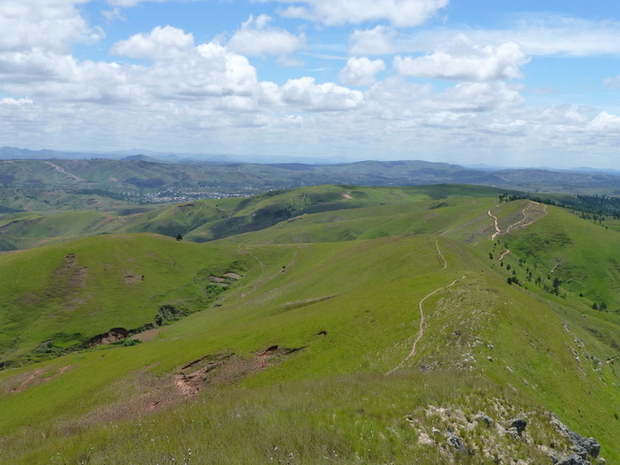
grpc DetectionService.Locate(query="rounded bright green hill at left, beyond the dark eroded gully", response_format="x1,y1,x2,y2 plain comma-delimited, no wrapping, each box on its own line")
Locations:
0,235,245,361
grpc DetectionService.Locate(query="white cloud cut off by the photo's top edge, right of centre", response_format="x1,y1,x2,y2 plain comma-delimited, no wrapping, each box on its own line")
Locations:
263,0,449,27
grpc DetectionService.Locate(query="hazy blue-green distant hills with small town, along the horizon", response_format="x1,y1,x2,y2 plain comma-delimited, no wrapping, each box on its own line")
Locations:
0,147,620,195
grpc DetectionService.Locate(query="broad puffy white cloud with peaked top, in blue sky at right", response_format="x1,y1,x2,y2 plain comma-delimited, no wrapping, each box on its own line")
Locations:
394,35,529,82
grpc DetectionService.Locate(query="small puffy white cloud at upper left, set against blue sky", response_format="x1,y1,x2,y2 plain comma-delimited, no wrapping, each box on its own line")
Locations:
112,26,194,60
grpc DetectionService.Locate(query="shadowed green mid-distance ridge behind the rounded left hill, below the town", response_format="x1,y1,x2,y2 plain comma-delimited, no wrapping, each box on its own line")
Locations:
0,185,500,250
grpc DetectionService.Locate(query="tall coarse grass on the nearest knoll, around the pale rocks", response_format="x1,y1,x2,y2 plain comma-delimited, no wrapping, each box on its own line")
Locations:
4,372,562,464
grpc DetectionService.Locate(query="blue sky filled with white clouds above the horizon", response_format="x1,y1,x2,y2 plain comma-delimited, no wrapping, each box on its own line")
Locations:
0,0,620,169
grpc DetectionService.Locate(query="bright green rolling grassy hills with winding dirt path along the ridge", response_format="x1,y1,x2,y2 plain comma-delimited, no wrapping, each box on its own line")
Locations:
0,186,620,464
